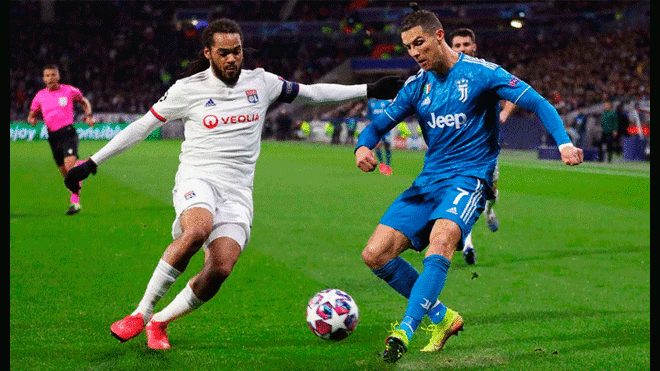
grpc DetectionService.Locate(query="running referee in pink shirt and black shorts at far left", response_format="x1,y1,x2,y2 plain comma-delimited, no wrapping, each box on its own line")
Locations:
27,65,94,215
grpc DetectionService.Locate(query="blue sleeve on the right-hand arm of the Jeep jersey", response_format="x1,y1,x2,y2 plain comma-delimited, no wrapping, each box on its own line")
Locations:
491,67,571,145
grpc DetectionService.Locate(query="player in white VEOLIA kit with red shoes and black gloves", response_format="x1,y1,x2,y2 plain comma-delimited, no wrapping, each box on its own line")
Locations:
65,19,403,349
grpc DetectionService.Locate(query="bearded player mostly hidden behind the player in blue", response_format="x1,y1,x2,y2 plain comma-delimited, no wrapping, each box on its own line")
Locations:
449,28,516,265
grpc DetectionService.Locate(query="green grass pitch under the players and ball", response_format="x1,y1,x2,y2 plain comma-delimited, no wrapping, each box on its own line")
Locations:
10,141,650,371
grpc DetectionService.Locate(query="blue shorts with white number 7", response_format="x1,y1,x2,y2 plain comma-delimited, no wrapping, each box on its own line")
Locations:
380,176,487,251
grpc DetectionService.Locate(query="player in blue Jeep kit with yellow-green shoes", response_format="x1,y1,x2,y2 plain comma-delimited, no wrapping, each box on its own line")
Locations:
355,3,583,363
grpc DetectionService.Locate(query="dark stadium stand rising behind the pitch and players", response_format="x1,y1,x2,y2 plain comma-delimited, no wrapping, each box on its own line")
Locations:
10,0,651,155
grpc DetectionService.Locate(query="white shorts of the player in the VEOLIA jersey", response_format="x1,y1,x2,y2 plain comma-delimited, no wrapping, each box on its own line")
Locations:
172,179,253,250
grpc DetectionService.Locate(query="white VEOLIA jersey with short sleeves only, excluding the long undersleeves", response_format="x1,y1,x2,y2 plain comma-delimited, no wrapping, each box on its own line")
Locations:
151,68,286,187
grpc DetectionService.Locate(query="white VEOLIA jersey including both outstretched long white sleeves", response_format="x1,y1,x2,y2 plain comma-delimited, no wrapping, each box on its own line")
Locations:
91,67,366,187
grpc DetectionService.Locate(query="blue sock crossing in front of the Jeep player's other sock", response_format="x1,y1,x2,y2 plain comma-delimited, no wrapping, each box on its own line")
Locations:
401,254,451,340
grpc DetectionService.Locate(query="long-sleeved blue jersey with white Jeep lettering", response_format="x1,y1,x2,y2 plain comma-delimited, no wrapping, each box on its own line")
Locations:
355,53,570,192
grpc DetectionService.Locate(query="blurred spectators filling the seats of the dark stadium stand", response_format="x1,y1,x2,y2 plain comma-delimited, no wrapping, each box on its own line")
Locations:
9,0,651,120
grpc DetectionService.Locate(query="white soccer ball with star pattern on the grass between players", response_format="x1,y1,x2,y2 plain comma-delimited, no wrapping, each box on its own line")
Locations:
307,289,359,341
